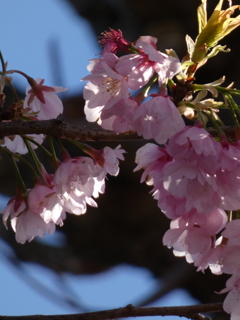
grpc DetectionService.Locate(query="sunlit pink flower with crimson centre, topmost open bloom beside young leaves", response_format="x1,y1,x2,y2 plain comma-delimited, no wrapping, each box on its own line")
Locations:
116,36,181,90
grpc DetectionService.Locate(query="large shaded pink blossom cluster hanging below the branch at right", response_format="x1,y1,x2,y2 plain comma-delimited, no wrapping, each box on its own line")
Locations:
135,126,240,319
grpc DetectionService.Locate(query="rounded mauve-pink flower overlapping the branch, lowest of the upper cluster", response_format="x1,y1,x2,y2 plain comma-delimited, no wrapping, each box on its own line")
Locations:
133,95,185,144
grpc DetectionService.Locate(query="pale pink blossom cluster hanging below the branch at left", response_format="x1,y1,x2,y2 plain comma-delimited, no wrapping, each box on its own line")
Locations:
1,147,125,243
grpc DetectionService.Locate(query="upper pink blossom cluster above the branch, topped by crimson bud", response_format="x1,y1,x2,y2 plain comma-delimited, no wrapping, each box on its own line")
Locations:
82,30,184,143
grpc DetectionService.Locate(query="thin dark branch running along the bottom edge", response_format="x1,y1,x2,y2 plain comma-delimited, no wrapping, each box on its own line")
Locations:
0,303,223,320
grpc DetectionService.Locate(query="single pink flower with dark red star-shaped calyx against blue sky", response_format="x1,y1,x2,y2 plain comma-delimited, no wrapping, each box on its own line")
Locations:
24,78,67,120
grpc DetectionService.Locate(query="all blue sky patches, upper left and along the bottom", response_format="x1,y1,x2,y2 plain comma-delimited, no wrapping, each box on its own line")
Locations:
0,0,195,319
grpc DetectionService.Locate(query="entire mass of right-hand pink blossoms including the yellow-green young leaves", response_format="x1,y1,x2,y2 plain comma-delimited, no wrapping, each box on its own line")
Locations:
82,1,240,319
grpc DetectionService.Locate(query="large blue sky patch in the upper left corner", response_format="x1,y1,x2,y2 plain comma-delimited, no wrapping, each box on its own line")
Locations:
0,0,100,94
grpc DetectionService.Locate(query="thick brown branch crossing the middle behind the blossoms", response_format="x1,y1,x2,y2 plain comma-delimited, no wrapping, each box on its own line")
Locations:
0,119,235,141
